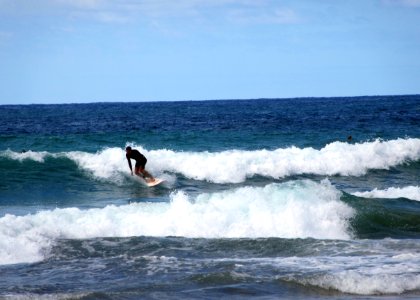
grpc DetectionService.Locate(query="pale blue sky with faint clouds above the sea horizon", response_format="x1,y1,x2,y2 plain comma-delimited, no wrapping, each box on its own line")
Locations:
0,0,420,104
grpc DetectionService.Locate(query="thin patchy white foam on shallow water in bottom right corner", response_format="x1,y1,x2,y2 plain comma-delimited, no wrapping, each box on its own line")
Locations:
278,239,420,295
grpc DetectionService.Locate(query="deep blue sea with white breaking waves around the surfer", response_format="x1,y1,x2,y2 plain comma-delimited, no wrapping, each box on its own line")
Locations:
0,95,420,299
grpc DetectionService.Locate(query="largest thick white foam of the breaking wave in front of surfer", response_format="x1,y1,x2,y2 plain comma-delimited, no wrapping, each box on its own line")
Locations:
0,181,354,264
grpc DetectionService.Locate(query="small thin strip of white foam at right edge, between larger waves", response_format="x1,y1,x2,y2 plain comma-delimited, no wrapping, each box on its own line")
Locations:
353,186,420,201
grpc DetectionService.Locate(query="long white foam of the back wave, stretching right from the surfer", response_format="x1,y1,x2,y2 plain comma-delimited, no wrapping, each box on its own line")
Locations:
149,139,420,183
